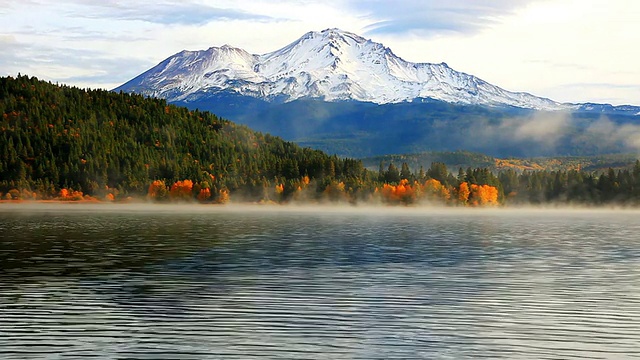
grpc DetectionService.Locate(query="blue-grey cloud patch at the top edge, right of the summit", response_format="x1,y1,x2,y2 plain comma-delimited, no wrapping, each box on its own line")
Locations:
349,0,533,35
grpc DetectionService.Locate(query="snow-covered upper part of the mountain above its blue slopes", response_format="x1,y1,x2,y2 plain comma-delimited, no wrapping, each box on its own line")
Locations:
115,29,571,110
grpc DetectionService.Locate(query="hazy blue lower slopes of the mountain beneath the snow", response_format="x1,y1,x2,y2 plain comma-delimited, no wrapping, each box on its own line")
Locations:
176,95,640,158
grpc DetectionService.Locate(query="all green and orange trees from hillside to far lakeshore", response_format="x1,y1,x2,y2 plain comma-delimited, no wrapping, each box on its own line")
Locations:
0,76,640,205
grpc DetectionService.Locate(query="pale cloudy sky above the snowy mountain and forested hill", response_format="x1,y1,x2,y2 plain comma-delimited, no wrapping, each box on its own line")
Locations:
0,0,640,105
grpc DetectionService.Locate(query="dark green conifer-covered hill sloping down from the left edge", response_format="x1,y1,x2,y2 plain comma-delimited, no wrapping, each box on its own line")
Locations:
0,75,366,201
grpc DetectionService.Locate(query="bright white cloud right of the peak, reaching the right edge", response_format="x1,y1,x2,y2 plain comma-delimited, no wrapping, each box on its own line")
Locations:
380,0,640,103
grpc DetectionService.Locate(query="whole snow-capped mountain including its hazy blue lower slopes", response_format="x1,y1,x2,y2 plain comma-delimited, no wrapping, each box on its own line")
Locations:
115,29,640,157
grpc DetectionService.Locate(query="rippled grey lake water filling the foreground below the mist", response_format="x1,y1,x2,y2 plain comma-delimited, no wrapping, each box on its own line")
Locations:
0,204,640,359
